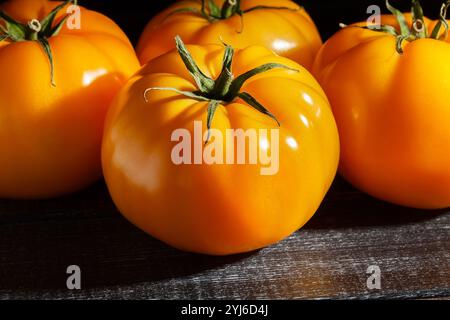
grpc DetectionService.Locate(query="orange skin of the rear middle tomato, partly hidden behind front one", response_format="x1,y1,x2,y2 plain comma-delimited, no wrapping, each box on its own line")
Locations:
136,0,322,70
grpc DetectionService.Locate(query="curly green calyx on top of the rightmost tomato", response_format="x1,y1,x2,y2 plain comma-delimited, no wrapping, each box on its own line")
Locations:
342,0,450,54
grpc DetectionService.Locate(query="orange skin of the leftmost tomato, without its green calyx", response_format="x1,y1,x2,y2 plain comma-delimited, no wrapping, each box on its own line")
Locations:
0,0,139,198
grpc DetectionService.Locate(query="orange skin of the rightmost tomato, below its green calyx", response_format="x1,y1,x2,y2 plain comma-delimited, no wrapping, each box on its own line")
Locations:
313,14,450,209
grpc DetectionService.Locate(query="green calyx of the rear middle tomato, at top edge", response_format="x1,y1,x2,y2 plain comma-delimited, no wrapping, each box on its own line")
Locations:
166,0,298,30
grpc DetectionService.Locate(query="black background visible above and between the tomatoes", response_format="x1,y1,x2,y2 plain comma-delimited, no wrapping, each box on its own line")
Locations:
79,0,444,43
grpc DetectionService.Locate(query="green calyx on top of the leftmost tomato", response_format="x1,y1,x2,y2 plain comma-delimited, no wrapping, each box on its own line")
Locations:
0,0,77,87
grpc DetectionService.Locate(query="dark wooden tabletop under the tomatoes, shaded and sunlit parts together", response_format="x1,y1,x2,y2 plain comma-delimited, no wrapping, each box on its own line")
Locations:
0,179,450,299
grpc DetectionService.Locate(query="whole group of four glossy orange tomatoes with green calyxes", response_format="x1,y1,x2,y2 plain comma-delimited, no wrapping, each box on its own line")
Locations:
0,0,450,255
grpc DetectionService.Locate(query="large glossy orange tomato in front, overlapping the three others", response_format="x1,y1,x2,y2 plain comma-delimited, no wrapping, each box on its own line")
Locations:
102,36,339,255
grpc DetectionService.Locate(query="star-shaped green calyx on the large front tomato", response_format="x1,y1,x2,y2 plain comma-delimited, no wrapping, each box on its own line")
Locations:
144,36,298,143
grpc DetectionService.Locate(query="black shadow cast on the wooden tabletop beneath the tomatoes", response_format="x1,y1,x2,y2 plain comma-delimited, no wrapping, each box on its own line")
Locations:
0,178,448,296
